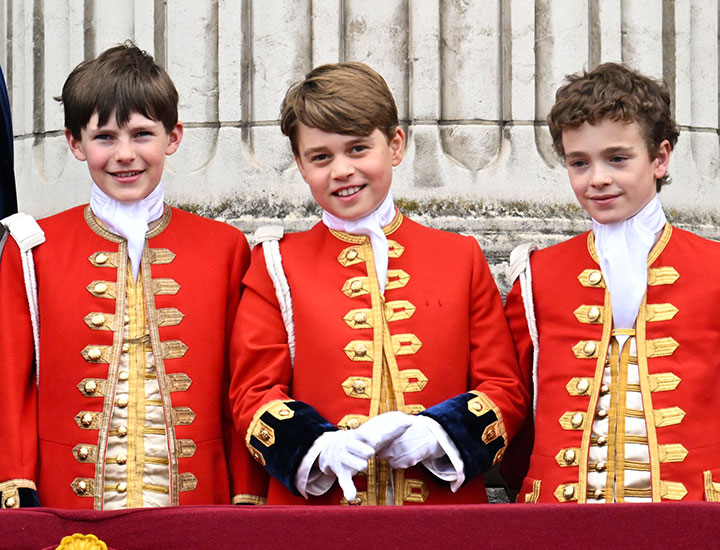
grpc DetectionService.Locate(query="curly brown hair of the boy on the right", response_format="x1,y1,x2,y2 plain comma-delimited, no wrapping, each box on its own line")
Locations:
547,63,679,191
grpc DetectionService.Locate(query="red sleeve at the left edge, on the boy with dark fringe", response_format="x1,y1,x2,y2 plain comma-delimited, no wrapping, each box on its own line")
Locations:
0,238,38,508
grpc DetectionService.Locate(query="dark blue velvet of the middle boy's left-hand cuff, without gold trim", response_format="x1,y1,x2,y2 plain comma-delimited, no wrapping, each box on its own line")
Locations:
250,401,338,496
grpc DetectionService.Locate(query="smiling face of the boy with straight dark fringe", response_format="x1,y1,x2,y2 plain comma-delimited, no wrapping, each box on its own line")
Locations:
65,113,183,202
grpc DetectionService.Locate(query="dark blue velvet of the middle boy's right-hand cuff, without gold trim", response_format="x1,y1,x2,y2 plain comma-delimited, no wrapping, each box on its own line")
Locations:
419,393,505,482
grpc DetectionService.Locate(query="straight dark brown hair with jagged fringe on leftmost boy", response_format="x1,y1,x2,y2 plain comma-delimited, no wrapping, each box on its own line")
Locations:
55,40,178,139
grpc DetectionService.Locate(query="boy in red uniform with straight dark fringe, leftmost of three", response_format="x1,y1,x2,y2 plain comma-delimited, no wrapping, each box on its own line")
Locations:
0,44,264,509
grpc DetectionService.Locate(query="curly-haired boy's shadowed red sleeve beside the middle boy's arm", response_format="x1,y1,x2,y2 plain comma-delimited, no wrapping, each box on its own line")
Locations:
500,280,534,491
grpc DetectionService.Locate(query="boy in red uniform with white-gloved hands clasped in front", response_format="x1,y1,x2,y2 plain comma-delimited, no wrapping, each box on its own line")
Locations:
231,63,527,505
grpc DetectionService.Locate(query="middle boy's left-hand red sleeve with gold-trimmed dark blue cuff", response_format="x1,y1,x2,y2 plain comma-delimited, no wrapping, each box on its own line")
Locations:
230,246,337,495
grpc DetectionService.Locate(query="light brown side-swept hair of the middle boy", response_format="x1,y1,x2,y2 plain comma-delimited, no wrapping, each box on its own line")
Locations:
280,62,398,156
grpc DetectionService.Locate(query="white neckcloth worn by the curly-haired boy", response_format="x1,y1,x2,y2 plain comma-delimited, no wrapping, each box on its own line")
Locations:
593,195,666,329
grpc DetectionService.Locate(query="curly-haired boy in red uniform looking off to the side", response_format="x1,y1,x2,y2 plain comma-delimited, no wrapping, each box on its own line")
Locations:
506,63,720,502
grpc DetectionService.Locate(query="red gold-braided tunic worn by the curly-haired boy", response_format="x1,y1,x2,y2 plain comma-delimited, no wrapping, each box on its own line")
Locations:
506,225,720,502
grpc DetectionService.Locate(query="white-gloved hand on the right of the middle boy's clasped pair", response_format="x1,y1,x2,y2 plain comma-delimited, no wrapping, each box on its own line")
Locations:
376,413,445,469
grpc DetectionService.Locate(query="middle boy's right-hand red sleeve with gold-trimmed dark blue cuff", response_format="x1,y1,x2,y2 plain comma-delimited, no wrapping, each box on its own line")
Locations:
420,238,528,481
